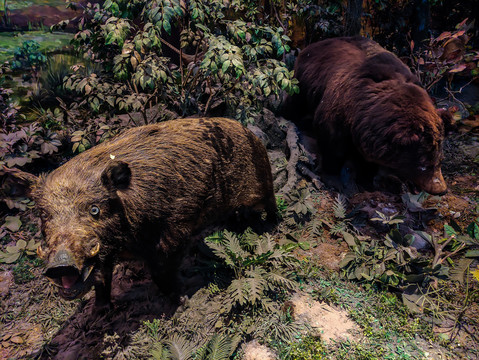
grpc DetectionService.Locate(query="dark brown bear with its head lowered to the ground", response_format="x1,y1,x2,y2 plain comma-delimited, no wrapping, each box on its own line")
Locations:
284,37,451,195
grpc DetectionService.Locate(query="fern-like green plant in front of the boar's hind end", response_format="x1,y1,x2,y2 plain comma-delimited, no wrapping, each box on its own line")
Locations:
205,231,296,311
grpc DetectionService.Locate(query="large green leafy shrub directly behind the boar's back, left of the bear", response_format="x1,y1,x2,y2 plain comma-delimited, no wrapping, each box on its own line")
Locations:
59,0,298,122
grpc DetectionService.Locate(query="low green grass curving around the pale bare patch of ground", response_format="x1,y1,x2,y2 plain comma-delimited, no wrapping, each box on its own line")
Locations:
275,262,454,360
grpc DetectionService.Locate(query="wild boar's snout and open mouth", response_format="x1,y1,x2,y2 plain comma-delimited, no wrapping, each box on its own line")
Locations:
44,250,94,300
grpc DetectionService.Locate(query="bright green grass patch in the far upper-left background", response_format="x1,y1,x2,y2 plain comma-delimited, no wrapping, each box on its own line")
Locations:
0,30,73,62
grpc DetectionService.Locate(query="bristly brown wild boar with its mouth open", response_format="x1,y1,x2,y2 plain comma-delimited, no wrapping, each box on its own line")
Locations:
32,118,276,305
